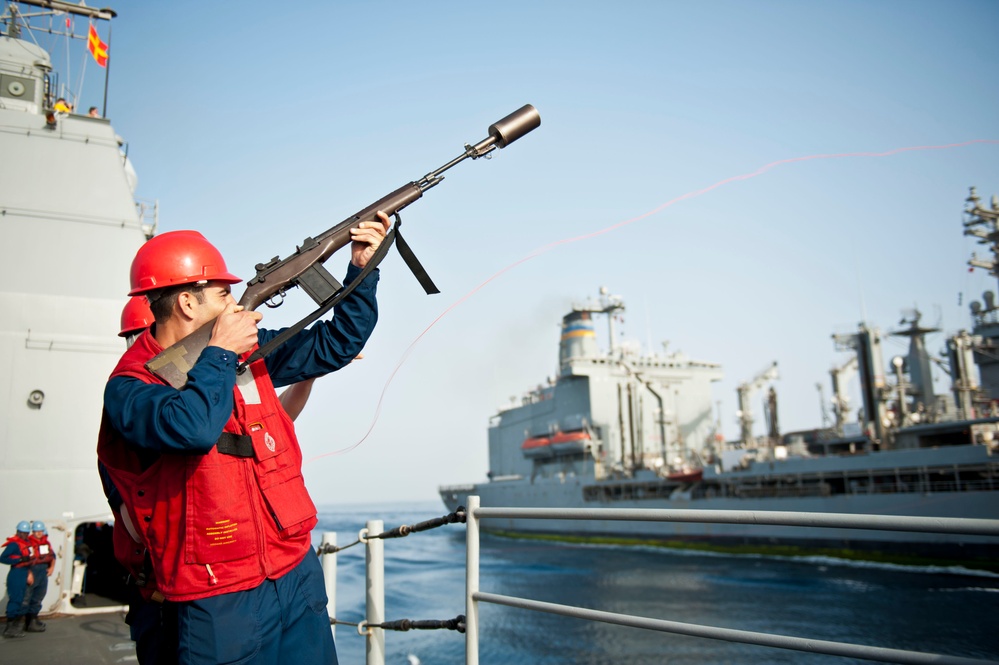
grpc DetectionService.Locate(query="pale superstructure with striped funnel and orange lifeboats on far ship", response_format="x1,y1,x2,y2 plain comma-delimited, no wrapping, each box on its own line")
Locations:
489,289,722,488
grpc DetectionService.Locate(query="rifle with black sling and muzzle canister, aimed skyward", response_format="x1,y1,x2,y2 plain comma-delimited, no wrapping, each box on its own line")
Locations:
146,104,541,389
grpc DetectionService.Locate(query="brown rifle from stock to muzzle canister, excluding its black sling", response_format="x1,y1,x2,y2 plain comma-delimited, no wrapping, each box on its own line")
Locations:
146,104,541,389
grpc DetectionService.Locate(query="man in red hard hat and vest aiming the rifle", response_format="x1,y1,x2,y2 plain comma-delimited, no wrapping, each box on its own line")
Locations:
98,214,388,663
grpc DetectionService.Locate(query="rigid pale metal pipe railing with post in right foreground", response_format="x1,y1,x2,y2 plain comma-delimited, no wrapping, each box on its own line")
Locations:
465,496,999,665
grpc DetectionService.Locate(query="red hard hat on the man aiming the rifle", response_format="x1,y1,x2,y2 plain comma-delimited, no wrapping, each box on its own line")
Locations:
128,231,243,296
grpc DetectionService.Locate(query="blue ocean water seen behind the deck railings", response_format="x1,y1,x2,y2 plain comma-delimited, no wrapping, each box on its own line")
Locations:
316,503,999,665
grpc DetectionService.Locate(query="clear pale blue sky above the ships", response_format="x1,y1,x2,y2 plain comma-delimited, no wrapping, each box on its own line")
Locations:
52,0,999,503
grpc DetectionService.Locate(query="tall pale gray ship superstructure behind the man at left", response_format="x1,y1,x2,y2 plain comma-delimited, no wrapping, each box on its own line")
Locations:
0,0,155,612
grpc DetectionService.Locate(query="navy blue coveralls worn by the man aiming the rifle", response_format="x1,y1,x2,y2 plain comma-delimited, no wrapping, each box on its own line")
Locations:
104,264,378,665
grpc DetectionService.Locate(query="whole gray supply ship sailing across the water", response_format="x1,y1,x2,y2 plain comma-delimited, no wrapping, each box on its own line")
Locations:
440,195,999,567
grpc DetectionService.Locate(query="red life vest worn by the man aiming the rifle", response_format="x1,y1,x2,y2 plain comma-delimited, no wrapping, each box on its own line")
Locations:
97,330,317,601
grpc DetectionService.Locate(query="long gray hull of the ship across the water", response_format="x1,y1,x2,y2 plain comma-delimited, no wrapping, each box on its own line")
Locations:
441,446,999,563
